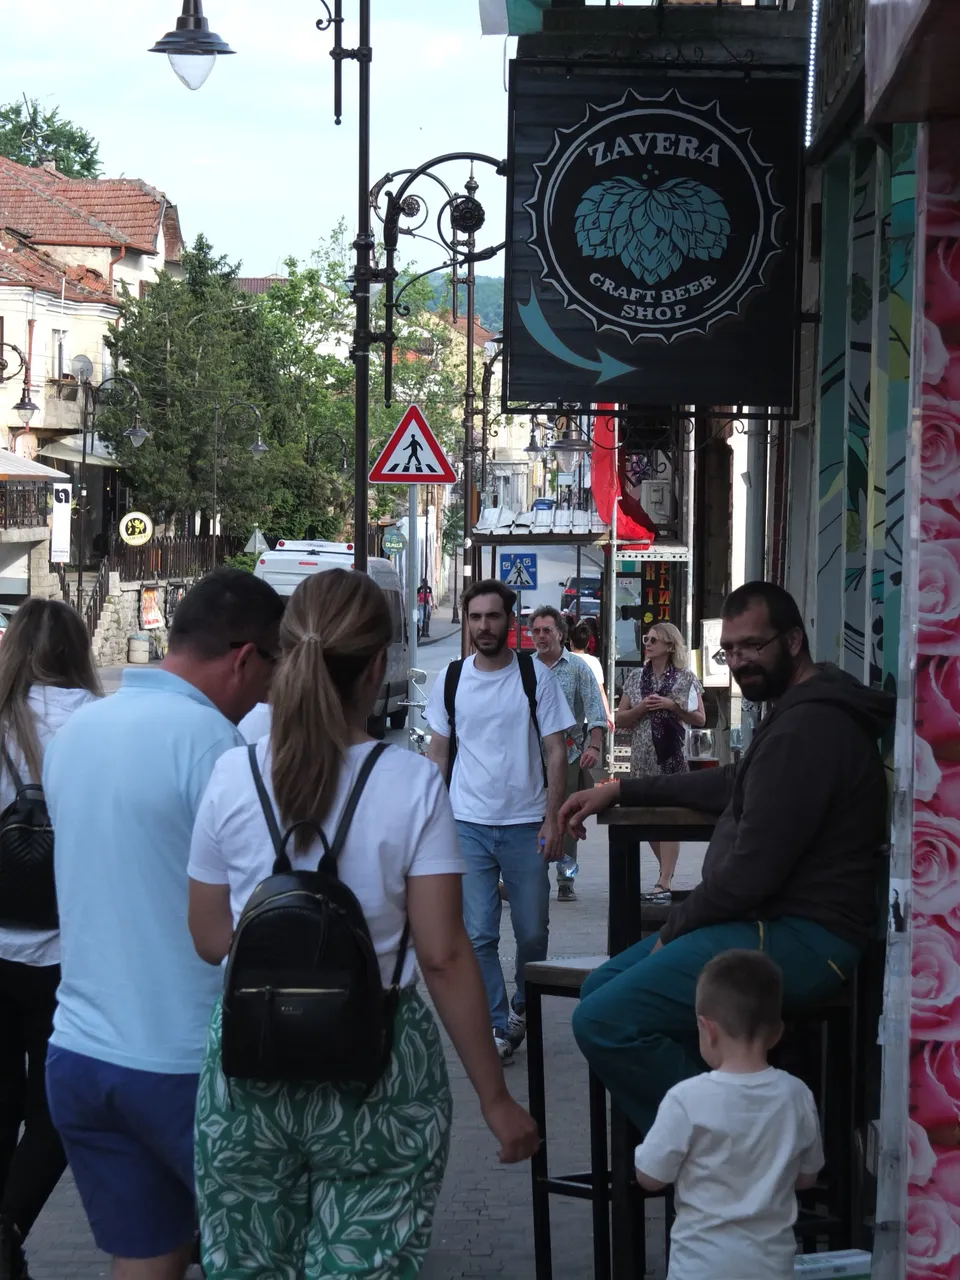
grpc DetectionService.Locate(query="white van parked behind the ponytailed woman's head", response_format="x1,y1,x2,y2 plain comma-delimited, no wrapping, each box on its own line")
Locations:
253,538,410,737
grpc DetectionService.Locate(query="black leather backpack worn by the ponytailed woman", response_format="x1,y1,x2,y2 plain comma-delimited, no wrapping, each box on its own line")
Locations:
221,742,410,1089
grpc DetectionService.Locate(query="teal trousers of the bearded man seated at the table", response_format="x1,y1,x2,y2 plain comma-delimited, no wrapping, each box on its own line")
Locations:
573,916,860,1133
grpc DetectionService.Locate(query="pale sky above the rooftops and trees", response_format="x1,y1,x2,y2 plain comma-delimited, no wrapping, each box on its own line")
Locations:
0,0,516,275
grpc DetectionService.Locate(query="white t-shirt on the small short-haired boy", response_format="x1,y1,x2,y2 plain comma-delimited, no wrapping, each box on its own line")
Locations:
635,1066,823,1280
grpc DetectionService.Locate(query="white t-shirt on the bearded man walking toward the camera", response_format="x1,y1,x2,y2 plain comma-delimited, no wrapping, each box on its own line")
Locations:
426,657,573,827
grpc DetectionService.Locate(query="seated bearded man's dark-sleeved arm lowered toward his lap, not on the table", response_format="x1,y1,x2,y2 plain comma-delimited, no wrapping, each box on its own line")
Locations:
660,727,840,943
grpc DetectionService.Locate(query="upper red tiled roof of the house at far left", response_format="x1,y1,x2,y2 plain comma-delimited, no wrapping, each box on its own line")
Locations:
0,156,183,261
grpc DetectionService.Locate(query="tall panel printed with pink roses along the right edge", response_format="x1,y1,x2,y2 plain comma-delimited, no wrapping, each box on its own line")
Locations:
908,122,960,1280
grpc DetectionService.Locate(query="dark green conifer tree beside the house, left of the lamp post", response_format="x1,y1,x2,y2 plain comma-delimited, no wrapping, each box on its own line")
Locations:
99,236,338,536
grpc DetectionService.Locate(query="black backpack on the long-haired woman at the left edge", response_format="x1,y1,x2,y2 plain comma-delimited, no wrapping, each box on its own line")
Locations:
0,744,59,929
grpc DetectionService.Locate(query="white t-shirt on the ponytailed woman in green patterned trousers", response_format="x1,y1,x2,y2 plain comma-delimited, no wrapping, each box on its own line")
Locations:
187,741,466,987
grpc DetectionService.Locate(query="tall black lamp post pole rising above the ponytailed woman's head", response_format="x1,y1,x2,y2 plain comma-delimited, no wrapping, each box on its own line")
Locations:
353,0,374,573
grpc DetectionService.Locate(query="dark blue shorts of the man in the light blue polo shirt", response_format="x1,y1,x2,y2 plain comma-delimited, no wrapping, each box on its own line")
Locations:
46,1044,198,1258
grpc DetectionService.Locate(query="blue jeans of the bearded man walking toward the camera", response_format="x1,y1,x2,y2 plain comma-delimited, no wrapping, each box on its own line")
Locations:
457,822,550,1033
